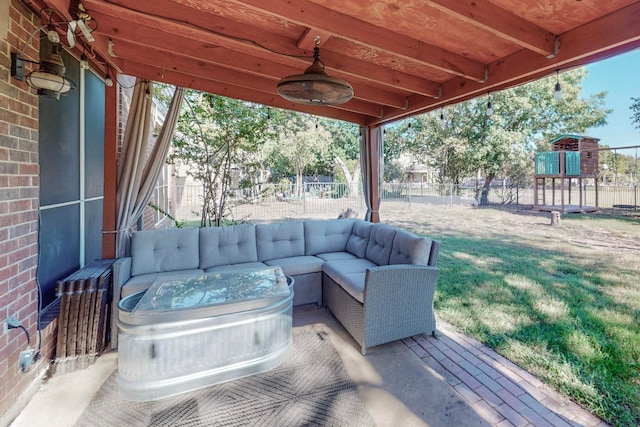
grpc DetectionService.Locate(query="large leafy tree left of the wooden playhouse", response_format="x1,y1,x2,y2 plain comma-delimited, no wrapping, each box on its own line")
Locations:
384,69,610,203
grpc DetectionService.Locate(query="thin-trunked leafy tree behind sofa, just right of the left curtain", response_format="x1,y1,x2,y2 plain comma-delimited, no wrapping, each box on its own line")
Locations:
169,90,269,227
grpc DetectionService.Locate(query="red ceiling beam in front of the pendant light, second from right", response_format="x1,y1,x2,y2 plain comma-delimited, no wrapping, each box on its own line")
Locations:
235,0,485,81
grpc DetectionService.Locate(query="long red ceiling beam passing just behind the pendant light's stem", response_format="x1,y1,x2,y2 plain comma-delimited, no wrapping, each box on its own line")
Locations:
86,0,439,96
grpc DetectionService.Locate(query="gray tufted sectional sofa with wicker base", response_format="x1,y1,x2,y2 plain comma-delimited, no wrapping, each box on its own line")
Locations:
112,218,439,354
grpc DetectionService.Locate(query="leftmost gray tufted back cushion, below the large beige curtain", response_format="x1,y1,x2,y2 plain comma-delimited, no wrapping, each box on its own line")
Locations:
131,228,200,276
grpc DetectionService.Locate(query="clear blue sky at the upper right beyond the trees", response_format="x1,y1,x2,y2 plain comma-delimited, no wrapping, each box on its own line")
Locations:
582,49,640,147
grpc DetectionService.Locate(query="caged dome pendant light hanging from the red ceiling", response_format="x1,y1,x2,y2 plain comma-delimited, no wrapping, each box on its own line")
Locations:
276,36,353,105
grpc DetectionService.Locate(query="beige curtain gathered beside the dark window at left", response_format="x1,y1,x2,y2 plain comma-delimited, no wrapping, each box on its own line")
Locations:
116,80,184,258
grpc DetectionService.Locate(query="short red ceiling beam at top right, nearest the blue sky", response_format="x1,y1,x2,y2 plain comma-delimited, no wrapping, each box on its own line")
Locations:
426,0,555,57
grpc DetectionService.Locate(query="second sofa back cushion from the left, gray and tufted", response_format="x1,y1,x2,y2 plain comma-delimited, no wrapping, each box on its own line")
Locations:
200,224,258,269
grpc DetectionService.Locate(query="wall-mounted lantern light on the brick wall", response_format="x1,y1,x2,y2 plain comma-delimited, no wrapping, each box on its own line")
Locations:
11,43,76,100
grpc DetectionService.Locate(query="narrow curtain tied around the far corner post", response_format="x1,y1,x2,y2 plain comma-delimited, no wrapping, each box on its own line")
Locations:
360,126,384,222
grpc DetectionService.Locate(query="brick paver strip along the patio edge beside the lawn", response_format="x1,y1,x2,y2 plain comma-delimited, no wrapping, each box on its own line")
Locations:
404,320,608,427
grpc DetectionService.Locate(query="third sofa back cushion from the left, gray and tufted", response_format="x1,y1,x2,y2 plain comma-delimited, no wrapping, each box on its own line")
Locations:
256,221,304,261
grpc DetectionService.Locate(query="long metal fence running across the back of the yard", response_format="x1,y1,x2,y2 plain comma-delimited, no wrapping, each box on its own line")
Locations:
171,182,640,221
